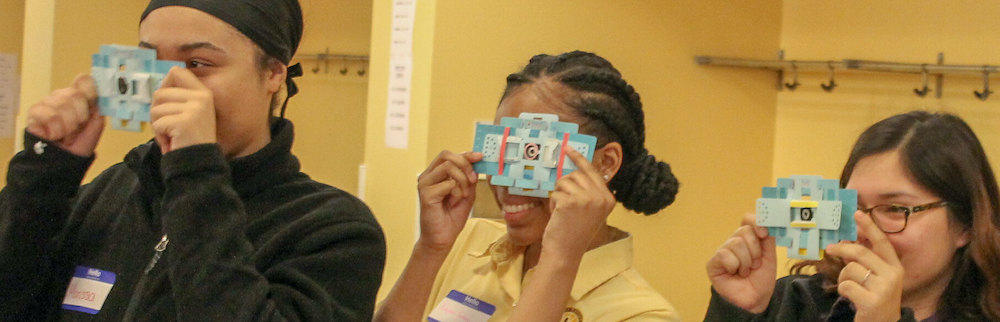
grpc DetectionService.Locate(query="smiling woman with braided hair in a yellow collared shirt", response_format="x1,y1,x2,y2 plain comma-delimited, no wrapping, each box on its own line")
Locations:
375,51,679,321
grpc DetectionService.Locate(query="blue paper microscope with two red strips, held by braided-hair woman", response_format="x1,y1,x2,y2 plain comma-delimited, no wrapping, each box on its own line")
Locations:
472,113,597,198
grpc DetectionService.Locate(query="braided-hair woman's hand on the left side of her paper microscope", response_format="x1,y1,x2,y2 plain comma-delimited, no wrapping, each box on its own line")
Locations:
417,150,483,252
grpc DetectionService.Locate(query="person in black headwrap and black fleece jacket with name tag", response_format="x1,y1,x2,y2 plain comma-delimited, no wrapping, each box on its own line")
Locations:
0,0,385,321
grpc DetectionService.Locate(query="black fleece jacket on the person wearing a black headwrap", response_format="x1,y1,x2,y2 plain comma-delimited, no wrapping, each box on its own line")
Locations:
0,120,385,321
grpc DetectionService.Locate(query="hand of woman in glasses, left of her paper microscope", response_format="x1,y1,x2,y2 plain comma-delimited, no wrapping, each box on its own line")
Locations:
705,214,777,313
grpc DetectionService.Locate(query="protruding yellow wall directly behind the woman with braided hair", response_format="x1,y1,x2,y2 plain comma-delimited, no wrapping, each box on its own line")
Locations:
366,0,781,320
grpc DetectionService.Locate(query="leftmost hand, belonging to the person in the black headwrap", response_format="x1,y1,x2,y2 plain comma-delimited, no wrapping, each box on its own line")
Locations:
26,74,104,157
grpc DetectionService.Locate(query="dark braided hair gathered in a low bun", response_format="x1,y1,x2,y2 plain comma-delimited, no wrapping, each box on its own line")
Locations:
501,51,679,215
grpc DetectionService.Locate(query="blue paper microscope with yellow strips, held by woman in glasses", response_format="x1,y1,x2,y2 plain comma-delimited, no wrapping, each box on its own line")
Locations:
756,176,858,260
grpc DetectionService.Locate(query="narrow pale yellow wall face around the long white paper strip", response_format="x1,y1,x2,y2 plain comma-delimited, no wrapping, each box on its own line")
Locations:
365,0,437,299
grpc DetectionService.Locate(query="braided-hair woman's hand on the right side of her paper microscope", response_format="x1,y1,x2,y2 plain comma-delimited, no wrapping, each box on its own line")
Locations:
542,149,615,259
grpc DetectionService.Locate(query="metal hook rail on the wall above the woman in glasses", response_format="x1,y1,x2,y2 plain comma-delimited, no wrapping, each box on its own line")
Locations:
694,54,1000,101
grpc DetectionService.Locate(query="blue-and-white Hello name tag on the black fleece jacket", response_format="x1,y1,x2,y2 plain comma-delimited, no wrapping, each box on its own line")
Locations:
63,266,115,314
